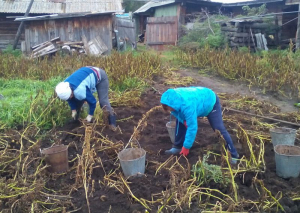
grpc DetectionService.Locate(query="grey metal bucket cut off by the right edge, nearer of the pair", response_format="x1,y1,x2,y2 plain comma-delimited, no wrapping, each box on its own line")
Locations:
274,145,300,178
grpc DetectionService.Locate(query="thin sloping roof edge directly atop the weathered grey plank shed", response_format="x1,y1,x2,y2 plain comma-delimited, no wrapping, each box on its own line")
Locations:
15,11,114,21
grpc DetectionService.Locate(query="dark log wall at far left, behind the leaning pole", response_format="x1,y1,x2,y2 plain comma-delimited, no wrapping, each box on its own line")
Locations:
0,17,24,49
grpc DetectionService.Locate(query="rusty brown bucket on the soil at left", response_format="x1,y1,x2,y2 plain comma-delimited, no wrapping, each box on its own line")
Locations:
41,145,69,173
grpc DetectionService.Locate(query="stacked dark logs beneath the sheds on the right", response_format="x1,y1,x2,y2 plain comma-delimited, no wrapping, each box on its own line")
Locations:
221,20,268,50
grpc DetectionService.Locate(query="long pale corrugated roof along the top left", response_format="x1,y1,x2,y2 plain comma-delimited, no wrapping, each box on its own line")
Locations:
0,0,123,14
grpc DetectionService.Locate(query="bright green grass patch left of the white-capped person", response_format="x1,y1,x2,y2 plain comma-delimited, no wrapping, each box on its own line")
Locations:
0,77,68,128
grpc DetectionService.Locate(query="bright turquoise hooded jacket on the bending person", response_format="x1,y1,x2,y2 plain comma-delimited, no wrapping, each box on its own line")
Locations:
160,87,216,149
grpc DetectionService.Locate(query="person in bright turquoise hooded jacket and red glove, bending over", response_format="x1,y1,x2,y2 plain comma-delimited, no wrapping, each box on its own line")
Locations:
160,87,239,164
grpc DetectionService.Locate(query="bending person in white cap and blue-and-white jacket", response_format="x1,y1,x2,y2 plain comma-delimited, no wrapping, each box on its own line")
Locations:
55,66,116,128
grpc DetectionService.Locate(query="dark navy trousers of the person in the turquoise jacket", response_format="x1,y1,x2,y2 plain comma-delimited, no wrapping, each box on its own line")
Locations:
174,96,238,158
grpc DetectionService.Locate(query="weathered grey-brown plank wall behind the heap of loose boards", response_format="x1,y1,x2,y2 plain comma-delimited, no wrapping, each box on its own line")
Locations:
25,15,112,53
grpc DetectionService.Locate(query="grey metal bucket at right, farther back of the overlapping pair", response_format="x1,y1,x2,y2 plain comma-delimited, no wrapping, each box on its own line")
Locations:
270,127,297,147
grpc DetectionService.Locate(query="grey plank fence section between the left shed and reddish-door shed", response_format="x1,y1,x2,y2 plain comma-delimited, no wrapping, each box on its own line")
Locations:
115,18,136,45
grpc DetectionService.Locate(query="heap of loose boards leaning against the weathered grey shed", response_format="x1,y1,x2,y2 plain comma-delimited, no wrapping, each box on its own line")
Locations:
31,36,108,58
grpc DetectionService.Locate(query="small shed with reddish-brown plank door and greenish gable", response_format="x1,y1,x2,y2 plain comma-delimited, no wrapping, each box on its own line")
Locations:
134,0,222,50
